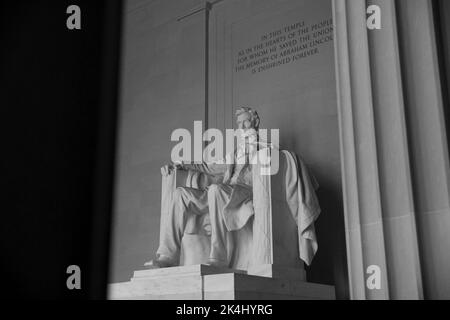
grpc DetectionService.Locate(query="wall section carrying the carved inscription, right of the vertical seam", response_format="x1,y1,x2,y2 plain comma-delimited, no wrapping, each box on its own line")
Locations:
208,0,347,298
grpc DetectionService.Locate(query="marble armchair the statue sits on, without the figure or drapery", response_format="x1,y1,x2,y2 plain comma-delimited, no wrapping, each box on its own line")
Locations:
162,150,316,280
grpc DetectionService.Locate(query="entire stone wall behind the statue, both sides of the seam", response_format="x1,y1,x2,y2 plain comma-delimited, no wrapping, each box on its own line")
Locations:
110,0,348,298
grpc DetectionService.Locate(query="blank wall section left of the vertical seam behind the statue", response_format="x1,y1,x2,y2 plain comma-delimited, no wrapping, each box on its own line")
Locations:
110,0,205,282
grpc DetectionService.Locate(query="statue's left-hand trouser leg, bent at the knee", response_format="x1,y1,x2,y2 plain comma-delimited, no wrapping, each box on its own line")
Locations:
156,187,208,261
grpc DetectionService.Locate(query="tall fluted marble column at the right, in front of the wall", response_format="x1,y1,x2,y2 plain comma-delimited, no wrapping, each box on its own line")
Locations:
333,0,450,299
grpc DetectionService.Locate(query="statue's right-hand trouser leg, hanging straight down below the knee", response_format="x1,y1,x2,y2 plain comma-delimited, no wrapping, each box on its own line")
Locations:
208,184,233,265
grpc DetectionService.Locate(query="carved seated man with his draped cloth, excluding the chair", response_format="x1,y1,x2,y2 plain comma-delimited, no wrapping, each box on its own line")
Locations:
145,107,320,268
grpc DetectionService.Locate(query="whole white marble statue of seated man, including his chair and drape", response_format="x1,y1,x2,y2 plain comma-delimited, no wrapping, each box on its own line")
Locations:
145,107,320,276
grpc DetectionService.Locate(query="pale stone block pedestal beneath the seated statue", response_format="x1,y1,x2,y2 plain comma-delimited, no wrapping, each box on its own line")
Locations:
108,265,335,300
